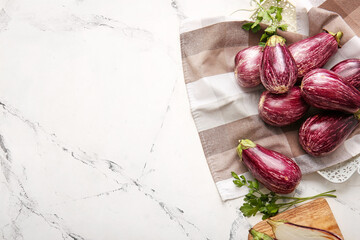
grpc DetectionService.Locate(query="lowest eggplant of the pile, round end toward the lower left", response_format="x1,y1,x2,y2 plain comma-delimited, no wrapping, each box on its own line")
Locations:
299,111,360,157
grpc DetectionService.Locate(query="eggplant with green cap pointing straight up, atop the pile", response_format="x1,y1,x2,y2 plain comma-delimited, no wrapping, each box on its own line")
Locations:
260,35,297,94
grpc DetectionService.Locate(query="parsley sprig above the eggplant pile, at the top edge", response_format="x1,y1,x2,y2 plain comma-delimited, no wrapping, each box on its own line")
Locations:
242,0,288,46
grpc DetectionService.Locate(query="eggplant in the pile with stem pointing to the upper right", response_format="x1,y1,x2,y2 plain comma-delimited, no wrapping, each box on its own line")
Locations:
289,32,342,77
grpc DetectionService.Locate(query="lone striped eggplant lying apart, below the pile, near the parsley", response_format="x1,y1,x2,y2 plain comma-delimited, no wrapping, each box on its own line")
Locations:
237,139,302,194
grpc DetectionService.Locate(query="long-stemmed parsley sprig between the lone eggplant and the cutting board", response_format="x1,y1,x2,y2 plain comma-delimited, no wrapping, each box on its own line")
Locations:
231,172,336,219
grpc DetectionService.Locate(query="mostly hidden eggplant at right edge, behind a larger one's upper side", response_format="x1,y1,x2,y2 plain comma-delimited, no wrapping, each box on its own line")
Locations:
331,58,360,90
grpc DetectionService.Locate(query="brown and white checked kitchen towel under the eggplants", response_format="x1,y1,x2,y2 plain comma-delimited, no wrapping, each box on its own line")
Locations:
180,0,360,201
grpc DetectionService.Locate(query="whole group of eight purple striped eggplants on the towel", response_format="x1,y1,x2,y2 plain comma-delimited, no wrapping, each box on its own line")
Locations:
234,31,360,193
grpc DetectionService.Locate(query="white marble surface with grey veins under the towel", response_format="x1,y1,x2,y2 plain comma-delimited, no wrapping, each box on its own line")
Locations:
0,0,360,240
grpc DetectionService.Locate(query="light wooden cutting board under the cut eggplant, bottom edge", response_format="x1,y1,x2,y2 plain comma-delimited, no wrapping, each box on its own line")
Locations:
248,198,343,240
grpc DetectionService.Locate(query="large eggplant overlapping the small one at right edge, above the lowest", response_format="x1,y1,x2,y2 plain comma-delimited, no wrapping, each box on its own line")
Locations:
300,68,360,113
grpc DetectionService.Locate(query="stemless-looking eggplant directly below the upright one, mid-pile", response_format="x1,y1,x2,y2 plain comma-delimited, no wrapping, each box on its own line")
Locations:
258,86,309,127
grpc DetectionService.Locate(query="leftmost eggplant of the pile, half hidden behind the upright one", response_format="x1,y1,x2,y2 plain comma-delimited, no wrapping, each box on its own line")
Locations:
234,46,263,87
